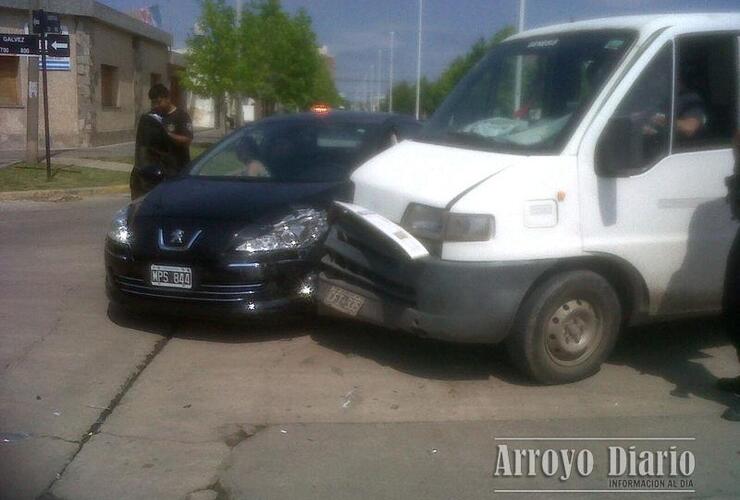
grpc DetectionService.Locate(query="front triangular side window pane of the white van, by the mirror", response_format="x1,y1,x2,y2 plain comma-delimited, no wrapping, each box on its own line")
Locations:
596,43,673,176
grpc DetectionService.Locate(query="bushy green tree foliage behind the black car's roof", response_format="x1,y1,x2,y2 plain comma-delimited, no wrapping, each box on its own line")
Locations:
186,0,339,114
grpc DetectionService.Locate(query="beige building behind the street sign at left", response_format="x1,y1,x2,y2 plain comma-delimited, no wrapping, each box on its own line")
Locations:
0,0,186,150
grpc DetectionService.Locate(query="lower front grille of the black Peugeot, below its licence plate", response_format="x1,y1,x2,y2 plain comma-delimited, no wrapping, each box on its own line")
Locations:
114,275,263,304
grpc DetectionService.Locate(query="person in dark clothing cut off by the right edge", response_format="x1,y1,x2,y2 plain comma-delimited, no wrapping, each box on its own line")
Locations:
717,132,740,421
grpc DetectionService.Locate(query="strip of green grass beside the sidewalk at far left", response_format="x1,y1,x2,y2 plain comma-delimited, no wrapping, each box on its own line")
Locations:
0,163,129,192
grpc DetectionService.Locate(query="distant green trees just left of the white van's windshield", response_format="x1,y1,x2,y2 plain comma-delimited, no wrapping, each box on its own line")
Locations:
382,26,516,116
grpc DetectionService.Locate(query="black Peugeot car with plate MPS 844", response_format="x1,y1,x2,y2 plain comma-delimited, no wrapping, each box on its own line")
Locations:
105,112,415,317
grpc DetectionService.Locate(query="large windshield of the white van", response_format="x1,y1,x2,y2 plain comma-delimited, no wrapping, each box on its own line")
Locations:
419,31,635,154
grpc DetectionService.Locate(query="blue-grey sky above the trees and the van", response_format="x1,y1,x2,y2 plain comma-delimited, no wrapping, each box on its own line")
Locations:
99,0,740,100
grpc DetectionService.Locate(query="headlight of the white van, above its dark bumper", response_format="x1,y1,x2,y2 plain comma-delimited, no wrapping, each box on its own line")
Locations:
401,203,496,242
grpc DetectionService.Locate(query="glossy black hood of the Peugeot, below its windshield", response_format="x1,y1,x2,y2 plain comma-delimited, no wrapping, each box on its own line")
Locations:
134,177,349,223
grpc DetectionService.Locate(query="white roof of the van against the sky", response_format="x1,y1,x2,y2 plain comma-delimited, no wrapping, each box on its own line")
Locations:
508,12,740,40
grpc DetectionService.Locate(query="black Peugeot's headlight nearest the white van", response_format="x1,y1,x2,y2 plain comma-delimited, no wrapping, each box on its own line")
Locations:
236,208,329,253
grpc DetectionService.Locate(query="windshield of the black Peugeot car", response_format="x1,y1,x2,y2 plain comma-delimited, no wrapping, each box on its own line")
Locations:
189,119,380,182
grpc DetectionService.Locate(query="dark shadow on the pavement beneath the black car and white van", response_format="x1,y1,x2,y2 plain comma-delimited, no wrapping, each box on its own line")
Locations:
108,307,737,407
